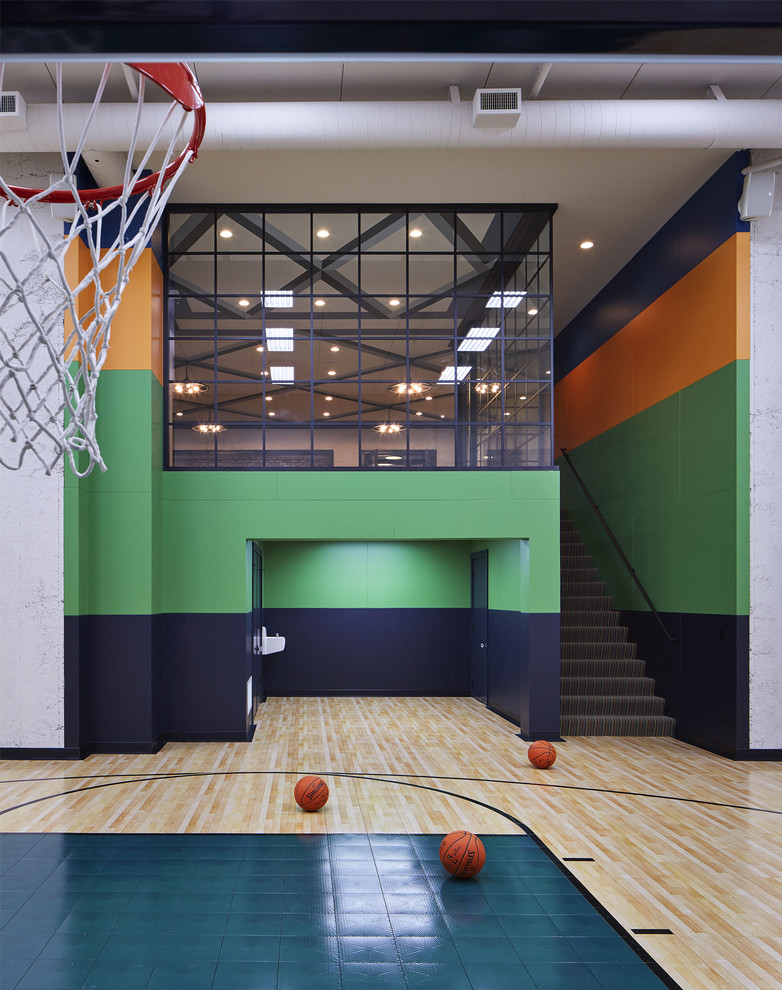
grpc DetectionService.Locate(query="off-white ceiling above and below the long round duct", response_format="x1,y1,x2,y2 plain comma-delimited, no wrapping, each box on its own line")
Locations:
0,57,782,330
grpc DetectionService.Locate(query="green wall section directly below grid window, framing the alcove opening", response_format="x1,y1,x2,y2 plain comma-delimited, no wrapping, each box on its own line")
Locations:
163,471,559,612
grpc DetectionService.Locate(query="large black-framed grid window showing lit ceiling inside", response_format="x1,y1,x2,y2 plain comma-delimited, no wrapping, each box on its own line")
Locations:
166,205,554,470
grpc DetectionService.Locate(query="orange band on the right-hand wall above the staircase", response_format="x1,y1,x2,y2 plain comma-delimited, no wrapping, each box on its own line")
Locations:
554,232,749,450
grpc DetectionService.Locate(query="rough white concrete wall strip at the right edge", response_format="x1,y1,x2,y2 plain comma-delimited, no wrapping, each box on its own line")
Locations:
749,149,782,749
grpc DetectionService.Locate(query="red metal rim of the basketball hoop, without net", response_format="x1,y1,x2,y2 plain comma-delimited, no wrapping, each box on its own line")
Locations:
0,62,206,203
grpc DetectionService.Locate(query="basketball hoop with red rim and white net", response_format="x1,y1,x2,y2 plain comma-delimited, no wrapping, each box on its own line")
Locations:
0,62,206,477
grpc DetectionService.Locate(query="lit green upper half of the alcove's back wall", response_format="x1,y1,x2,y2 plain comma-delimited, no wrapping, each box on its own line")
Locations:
263,540,470,608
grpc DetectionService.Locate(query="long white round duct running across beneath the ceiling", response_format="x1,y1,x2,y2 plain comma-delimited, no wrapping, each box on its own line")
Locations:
0,100,782,152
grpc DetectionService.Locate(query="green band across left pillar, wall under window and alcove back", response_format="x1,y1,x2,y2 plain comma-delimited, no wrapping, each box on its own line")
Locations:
65,370,559,615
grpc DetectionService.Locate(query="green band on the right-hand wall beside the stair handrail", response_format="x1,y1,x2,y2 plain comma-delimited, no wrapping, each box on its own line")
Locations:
559,361,749,615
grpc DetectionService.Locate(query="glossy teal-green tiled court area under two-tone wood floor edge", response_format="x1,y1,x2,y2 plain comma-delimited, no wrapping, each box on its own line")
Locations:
0,835,675,990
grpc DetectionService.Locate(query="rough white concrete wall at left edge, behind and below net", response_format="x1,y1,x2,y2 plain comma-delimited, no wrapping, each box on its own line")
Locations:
0,154,64,748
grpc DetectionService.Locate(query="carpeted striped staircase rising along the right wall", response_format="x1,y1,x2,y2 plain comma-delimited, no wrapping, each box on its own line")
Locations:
560,513,675,736
